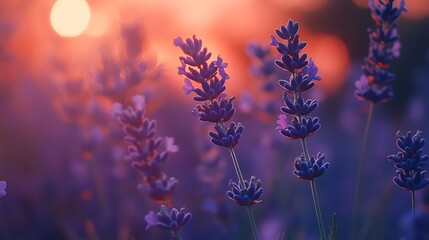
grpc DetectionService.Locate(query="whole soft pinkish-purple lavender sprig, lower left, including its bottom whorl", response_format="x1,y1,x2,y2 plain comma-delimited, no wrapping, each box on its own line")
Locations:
114,95,192,239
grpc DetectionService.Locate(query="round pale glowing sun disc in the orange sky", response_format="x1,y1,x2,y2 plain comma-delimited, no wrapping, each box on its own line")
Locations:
51,0,91,37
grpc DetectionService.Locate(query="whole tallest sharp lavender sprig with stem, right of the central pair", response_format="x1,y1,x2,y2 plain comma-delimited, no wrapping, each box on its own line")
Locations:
271,20,329,240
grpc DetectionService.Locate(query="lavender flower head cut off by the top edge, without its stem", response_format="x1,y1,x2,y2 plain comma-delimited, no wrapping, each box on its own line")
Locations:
355,0,407,102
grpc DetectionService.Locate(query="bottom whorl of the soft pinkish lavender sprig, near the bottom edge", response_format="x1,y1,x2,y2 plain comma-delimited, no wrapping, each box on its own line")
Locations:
145,205,192,235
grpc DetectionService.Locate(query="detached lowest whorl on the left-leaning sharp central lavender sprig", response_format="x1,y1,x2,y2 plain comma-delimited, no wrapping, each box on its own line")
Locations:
227,176,263,207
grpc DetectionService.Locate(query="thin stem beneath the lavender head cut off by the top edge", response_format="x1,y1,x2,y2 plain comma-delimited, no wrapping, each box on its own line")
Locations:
352,102,374,238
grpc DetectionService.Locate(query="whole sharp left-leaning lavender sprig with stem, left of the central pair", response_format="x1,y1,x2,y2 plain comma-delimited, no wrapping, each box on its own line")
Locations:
174,36,262,239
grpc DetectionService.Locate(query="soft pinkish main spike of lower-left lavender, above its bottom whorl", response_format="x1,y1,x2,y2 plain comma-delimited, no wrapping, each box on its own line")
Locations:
114,96,178,203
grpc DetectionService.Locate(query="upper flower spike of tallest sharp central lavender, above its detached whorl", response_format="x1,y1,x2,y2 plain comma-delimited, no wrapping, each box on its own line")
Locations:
271,20,321,139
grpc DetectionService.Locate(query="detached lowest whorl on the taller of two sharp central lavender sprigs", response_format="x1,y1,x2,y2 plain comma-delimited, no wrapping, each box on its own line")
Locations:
293,153,329,180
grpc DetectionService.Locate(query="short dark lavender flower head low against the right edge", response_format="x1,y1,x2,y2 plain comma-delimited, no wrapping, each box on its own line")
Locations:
388,131,429,191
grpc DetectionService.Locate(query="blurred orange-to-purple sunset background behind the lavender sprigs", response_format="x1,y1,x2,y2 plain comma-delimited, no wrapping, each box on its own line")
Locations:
0,0,429,240
